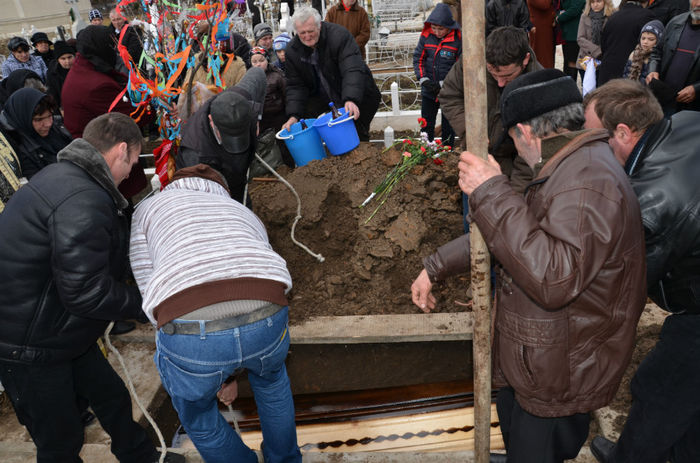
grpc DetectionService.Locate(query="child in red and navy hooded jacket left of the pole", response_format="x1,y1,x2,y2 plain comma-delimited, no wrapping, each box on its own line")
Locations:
413,3,462,145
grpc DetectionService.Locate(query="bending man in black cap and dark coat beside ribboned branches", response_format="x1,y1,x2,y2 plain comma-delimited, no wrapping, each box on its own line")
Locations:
175,67,266,203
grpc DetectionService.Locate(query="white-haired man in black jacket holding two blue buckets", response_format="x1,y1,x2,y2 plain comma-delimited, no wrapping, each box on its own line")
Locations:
283,6,381,141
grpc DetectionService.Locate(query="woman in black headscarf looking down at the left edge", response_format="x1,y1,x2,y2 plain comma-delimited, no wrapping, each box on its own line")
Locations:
0,88,72,179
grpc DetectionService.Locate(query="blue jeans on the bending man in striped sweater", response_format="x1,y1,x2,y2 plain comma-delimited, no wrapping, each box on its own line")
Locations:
155,307,301,463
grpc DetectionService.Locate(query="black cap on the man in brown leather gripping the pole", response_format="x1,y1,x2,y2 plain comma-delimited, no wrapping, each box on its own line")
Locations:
501,69,583,130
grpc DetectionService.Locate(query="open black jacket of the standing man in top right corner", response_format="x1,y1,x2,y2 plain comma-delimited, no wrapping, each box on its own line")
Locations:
649,13,700,111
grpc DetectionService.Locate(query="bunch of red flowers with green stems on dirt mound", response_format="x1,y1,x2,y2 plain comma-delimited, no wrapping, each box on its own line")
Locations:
360,117,452,223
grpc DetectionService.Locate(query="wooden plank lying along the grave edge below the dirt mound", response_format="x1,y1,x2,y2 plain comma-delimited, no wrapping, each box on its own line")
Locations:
289,312,474,344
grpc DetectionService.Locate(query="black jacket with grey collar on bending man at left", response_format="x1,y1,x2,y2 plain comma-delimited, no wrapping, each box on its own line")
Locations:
0,139,143,363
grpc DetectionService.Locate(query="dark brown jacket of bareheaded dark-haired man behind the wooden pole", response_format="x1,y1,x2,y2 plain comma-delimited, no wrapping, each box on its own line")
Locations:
439,50,542,193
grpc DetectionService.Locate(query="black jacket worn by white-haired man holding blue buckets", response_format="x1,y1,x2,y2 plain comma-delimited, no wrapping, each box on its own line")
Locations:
286,22,379,119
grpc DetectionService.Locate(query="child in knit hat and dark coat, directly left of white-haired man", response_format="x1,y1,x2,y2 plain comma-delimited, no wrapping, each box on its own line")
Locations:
250,47,294,167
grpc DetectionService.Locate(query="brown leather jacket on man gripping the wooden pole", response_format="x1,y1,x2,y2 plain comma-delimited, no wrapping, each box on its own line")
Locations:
424,130,646,417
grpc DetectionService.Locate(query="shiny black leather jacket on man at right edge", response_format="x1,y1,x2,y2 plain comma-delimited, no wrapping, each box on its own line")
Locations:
625,111,700,313
